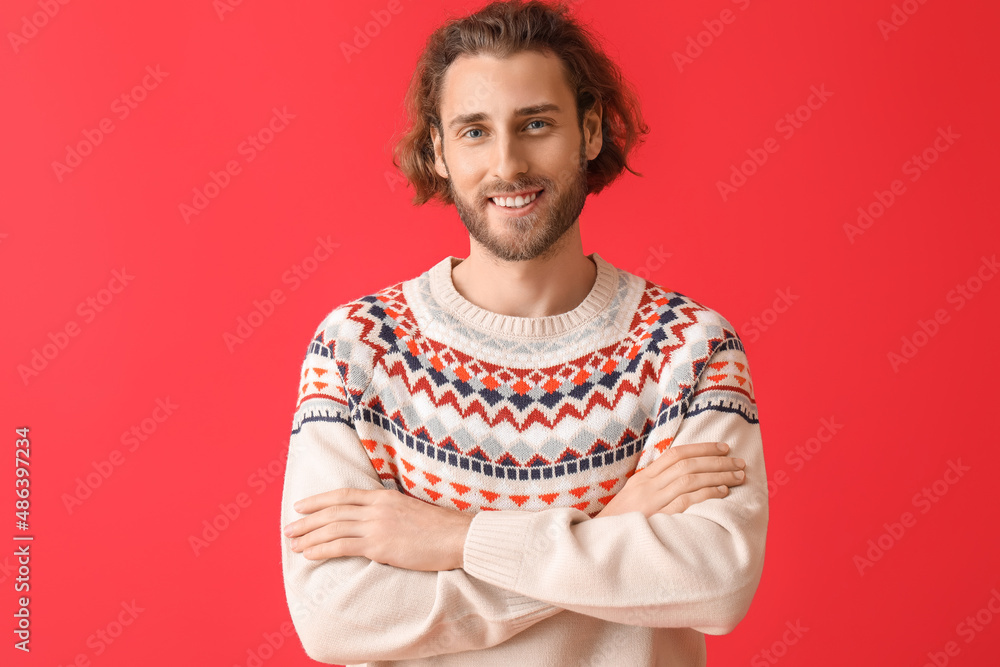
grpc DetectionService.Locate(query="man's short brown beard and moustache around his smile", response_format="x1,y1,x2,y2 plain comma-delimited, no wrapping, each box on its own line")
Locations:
445,140,587,262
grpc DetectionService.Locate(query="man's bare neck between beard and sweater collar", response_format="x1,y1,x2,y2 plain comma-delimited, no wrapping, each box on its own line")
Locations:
451,234,597,317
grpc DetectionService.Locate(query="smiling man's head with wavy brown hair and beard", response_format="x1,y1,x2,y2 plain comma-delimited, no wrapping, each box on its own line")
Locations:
394,0,649,261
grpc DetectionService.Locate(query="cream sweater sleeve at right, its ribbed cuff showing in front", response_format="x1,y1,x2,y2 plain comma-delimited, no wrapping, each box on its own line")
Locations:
464,333,768,634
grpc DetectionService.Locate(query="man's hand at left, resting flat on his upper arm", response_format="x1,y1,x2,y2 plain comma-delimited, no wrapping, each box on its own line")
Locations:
284,489,472,572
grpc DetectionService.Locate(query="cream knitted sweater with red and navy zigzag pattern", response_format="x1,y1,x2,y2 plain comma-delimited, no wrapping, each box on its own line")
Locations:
281,253,768,667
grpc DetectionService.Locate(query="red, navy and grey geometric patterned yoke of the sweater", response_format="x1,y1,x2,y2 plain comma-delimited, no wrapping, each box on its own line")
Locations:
293,265,757,516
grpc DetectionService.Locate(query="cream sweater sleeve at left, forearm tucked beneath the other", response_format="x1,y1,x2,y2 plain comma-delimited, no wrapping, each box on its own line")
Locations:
281,311,563,664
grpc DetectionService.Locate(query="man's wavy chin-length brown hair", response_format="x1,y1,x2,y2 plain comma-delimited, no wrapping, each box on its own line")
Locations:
392,0,649,206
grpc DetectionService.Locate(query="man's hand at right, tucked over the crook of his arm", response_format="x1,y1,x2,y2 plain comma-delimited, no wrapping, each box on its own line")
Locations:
594,442,746,519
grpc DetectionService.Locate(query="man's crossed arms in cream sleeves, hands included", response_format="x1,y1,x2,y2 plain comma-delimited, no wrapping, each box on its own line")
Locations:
281,332,767,663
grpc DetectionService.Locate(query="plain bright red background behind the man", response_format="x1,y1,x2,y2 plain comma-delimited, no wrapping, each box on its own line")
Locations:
0,0,1000,667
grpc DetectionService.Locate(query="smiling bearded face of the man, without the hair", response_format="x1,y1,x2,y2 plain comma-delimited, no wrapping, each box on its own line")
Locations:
432,51,601,261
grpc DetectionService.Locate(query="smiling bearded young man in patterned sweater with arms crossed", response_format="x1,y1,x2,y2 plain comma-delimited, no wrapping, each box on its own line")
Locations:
282,2,767,667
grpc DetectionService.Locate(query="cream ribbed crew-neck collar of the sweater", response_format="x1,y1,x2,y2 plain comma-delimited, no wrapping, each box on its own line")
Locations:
429,252,618,338
